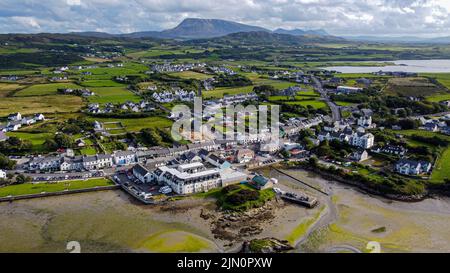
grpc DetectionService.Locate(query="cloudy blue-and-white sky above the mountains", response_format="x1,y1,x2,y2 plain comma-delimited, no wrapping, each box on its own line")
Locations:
0,0,450,37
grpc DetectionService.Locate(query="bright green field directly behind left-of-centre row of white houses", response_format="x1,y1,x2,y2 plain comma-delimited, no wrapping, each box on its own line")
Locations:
88,87,141,104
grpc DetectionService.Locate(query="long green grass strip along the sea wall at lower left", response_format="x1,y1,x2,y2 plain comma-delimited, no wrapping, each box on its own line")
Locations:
0,178,114,197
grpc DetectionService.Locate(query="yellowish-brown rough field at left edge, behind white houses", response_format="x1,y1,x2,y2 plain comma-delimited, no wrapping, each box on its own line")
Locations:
0,95,83,116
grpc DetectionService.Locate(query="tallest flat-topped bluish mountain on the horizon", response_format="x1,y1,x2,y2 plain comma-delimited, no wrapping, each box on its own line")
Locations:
123,18,270,39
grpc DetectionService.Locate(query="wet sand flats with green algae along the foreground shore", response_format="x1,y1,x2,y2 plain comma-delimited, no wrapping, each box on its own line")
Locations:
0,167,450,252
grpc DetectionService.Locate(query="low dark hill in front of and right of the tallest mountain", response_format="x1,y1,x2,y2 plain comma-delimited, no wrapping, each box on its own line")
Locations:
186,31,345,46
